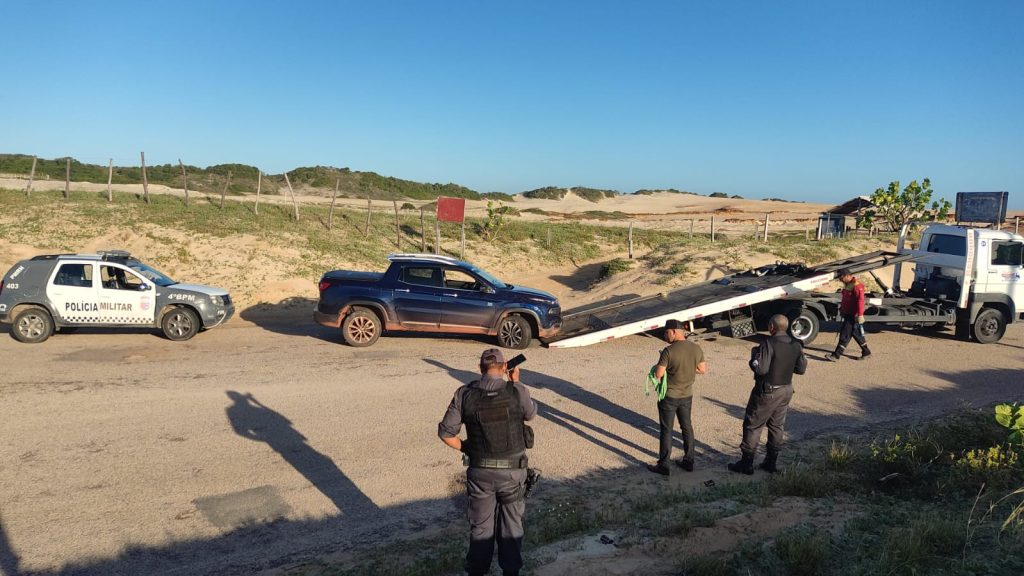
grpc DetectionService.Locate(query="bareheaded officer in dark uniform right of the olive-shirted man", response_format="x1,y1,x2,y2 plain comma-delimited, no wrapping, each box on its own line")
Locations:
728,314,807,475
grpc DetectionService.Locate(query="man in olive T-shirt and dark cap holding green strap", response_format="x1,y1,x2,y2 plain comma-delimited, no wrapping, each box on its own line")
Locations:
647,320,708,476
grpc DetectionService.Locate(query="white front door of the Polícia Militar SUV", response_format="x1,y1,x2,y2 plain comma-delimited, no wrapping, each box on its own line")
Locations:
99,262,157,325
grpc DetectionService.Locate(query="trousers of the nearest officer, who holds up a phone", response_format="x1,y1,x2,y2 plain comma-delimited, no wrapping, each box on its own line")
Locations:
465,467,526,575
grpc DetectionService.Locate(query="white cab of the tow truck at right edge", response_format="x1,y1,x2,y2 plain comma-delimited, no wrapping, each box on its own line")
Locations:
896,224,1024,342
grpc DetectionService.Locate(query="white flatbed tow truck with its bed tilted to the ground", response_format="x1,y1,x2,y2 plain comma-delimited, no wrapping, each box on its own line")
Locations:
543,220,1024,348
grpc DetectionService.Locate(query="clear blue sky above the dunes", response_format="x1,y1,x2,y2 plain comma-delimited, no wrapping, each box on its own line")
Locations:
0,0,1024,208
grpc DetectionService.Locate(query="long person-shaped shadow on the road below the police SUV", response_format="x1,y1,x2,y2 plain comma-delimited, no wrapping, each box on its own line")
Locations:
226,390,379,519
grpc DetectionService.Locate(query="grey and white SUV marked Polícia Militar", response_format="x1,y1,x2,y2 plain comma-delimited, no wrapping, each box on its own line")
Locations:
0,250,234,342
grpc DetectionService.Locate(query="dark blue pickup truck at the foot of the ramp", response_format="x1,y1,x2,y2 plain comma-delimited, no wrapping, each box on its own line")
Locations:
313,254,562,349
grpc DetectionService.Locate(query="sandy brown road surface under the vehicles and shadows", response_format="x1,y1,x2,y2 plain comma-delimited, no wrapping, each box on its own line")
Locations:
0,310,1024,576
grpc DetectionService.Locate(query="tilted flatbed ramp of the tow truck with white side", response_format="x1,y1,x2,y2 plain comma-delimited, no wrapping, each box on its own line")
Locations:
545,250,913,348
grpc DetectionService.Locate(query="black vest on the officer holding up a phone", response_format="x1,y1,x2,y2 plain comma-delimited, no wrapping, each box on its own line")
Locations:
462,382,526,459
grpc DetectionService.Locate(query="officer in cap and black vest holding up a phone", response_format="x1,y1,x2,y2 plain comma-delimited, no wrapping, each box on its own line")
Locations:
437,348,537,576
